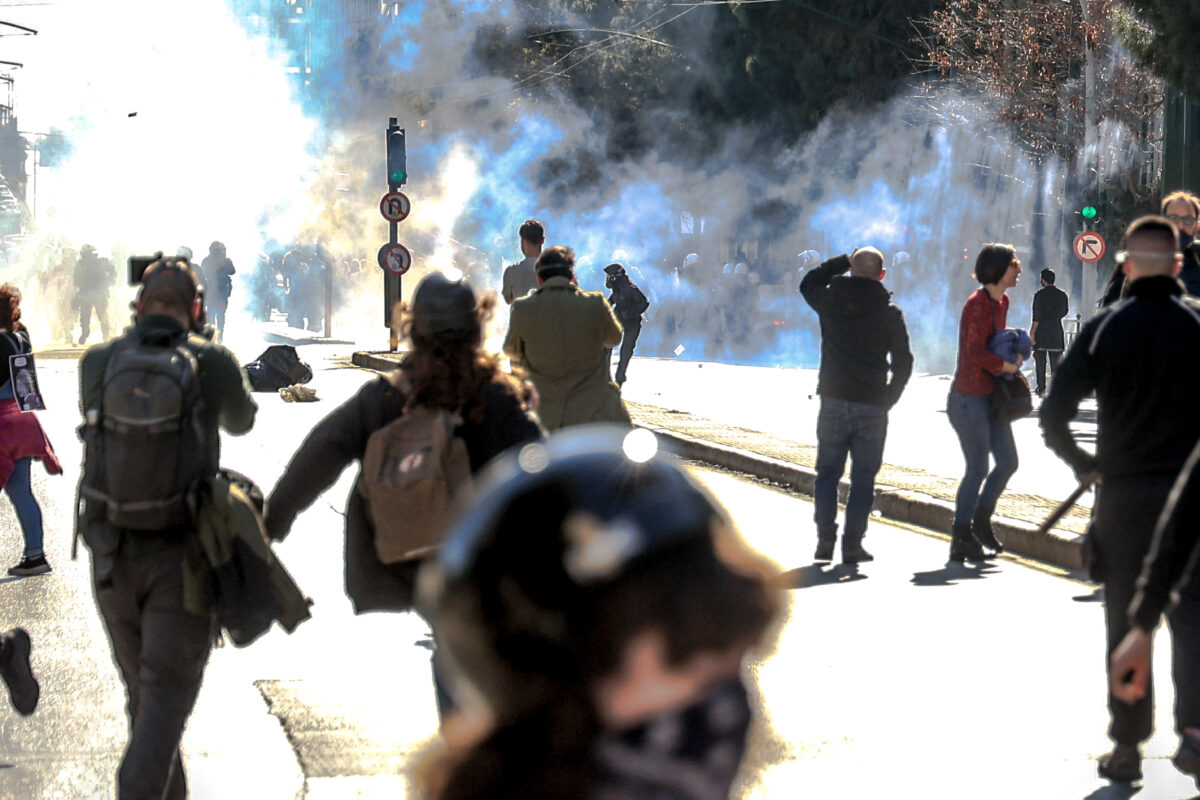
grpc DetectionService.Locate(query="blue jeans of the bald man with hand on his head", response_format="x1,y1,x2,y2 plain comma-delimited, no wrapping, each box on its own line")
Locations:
812,397,888,547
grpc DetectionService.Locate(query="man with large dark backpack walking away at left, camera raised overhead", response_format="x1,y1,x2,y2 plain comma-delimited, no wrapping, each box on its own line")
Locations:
78,257,258,800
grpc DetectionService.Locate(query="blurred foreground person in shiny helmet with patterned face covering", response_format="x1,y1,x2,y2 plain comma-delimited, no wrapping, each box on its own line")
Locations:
420,425,780,800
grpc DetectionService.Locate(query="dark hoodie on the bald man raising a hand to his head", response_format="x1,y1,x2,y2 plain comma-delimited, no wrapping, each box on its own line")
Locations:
800,255,912,408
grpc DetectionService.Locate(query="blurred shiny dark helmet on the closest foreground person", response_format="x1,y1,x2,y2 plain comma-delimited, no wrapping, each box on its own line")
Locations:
420,425,730,708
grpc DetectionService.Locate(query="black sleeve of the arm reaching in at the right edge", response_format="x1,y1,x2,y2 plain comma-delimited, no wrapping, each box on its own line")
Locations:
1129,445,1200,631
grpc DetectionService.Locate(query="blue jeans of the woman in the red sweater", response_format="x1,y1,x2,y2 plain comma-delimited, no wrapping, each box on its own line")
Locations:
946,389,1018,525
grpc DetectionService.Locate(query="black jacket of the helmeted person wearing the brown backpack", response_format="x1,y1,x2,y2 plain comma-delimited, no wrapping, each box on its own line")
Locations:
266,378,544,614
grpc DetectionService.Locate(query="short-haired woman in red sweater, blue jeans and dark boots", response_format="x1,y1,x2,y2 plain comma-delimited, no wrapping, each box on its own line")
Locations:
946,243,1021,561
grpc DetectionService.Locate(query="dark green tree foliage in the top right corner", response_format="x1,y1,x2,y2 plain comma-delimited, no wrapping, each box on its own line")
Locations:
1116,0,1200,98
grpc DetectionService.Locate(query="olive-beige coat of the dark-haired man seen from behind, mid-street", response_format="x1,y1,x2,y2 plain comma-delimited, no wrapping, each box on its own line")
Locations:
504,277,630,431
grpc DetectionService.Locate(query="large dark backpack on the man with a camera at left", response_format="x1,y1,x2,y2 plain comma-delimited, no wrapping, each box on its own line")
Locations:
80,335,208,530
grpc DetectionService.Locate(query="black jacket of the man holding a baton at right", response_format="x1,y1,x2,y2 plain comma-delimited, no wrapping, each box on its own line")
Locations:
1042,276,1200,477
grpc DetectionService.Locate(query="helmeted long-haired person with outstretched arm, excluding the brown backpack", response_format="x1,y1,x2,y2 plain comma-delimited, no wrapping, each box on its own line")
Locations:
265,272,544,700
